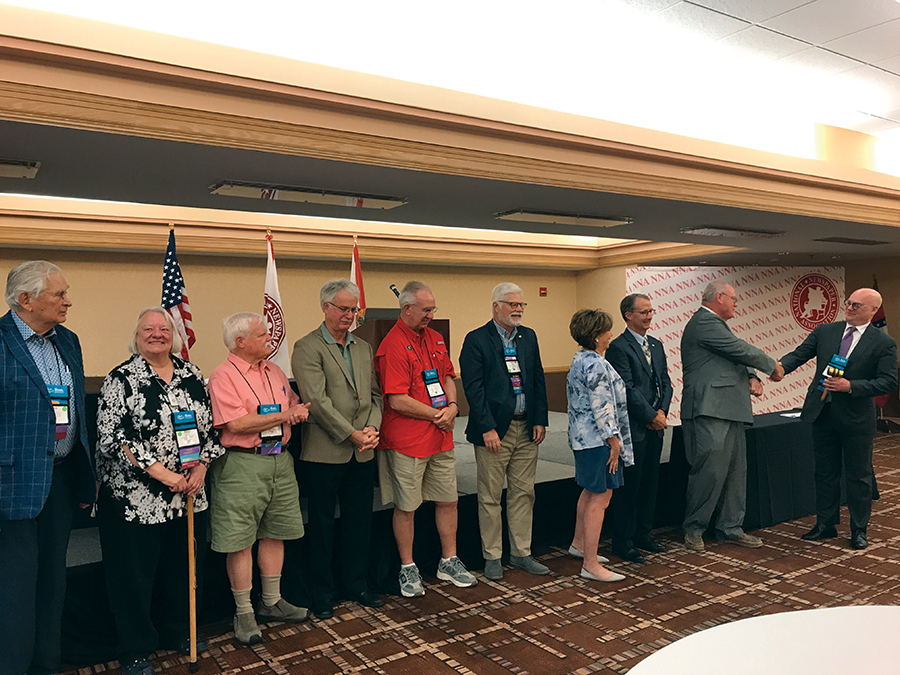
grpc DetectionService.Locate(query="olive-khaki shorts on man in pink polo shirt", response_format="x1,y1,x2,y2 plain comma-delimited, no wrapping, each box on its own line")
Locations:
209,451,303,553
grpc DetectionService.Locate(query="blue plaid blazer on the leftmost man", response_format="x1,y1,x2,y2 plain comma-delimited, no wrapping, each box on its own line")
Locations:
0,312,96,520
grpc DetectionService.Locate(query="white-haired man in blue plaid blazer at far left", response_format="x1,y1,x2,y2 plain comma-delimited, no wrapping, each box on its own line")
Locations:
0,260,96,675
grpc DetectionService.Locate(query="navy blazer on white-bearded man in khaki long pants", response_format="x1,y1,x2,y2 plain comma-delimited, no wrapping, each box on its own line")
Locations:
459,319,548,445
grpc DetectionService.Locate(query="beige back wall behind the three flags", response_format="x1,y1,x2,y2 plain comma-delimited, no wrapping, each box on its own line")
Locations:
0,248,625,376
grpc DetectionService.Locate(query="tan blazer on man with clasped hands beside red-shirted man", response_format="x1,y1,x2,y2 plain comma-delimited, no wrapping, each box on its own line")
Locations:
291,327,382,464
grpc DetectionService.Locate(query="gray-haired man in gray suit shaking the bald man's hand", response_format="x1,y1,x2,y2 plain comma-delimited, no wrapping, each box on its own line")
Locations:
681,281,784,551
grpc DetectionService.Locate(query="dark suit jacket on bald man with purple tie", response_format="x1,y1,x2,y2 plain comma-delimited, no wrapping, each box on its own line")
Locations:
781,321,897,434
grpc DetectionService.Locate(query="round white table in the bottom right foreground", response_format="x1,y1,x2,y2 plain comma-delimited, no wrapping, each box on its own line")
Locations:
628,606,900,675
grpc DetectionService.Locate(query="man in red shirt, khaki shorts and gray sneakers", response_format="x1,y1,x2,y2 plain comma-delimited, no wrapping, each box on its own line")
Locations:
375,281,477,598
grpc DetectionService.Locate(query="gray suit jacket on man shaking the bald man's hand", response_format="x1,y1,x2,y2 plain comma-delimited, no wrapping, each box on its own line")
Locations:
681,307,775,423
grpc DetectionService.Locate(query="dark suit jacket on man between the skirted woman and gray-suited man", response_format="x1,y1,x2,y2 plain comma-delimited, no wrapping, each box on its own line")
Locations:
605,330,672,443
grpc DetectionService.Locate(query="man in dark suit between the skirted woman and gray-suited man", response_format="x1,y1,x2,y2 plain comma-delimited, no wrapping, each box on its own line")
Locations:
606,293,672,563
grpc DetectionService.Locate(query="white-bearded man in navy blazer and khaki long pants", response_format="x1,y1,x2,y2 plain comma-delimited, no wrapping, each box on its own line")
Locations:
459,283,550,580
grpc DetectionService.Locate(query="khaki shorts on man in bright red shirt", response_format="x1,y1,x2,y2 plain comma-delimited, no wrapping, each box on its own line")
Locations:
378,448,459,511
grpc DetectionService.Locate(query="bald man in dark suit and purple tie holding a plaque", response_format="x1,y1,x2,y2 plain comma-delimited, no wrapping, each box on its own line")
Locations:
781,288,897,550
